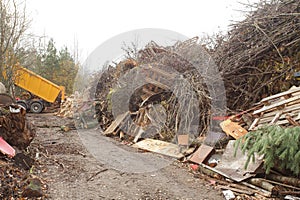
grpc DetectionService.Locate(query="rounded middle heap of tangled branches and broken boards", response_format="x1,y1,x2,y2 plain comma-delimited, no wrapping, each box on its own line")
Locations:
95,38,211,144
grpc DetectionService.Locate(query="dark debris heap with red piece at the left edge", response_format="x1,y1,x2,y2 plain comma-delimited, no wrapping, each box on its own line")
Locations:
0,94,44,199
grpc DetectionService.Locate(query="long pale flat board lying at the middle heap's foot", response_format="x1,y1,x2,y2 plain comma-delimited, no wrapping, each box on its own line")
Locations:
132,138,184,159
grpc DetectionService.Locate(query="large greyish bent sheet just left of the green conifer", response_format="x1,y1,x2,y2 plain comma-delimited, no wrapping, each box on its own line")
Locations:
215,140,263,182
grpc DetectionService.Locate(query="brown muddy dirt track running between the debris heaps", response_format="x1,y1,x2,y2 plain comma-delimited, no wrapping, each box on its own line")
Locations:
27,114,224,200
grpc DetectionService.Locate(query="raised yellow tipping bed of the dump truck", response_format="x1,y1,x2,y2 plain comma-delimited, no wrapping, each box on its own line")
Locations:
14,66,63,103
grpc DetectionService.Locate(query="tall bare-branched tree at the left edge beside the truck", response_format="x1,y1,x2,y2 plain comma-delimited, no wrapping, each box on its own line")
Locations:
0,0,30,92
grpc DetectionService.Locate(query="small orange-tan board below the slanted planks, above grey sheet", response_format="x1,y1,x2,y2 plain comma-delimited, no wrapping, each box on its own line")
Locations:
220,119,248,139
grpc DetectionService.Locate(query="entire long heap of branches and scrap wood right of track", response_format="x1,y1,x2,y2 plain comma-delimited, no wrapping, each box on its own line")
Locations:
72,0,300,199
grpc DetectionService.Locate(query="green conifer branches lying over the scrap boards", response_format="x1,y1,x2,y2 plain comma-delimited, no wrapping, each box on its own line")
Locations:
235,125,300,176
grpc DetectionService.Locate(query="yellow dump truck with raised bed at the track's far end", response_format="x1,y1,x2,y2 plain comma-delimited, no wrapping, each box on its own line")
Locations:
14,65,65,113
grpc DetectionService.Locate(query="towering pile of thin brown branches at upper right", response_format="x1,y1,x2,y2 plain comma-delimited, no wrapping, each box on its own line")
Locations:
210,0,300,110
